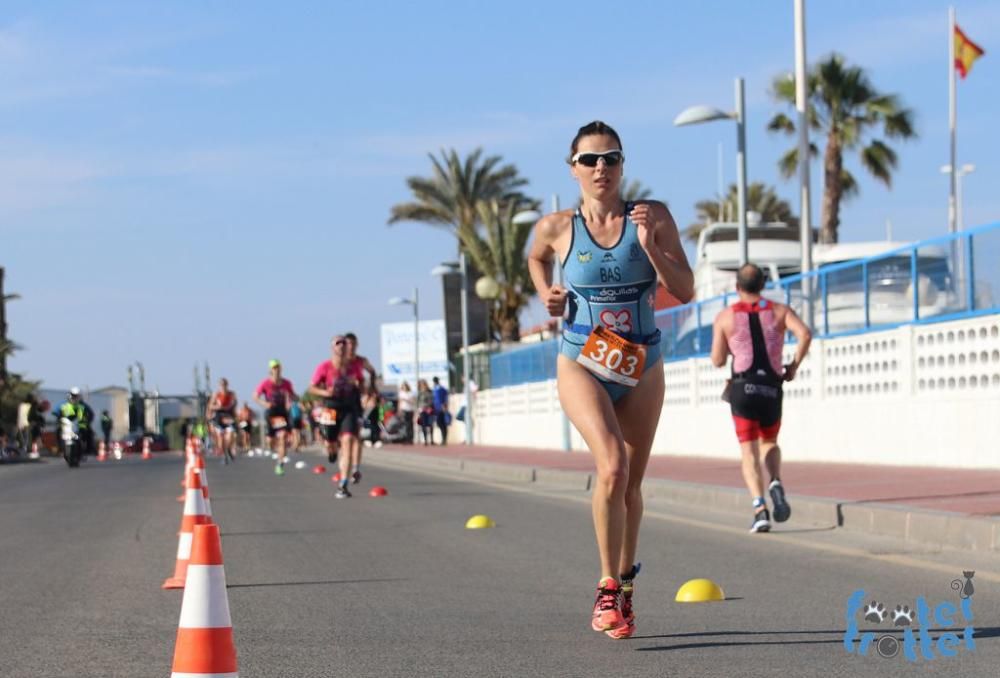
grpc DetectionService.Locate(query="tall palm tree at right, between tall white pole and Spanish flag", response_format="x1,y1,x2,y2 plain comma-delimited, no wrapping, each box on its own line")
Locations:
767,54,916,243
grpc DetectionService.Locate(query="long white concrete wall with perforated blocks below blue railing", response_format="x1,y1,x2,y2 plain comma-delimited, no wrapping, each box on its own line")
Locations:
475,315,1000,468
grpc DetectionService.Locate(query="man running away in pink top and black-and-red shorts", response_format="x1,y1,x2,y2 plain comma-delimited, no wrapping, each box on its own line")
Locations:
712,264,812,532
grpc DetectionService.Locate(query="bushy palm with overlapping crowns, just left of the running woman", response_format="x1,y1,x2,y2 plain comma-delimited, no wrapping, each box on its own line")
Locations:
389,148,539,341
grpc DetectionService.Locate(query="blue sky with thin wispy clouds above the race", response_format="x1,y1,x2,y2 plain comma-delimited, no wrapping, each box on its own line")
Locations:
0,0,1000,404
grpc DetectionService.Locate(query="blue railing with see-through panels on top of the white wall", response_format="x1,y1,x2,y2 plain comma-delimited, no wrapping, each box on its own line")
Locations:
490,222,1000,388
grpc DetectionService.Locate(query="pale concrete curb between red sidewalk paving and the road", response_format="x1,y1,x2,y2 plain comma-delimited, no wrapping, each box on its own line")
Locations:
365,449,1000,552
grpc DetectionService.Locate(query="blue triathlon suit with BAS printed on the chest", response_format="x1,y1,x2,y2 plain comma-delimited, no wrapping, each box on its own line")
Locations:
559,203,662,402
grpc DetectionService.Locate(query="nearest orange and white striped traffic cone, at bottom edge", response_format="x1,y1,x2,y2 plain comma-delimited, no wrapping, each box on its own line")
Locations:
170,525,239,678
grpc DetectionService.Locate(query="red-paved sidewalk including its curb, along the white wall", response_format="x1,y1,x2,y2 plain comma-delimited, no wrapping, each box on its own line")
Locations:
366,445,1000,551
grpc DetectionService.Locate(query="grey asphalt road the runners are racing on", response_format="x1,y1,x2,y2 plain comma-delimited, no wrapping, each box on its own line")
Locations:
0,455,1000,678
